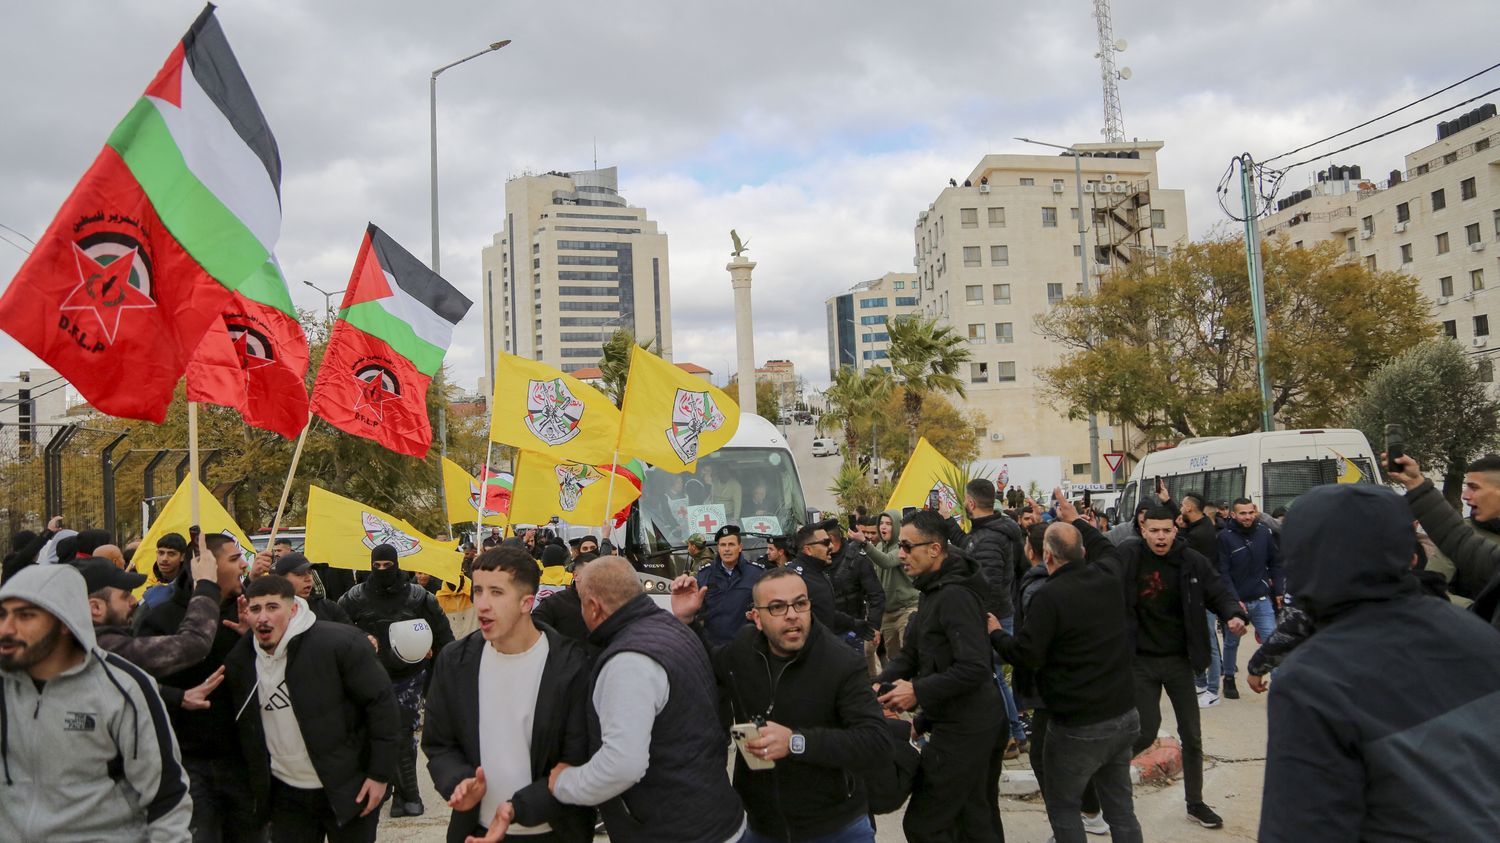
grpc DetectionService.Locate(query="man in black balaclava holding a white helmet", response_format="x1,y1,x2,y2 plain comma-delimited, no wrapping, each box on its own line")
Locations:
339,545,453,818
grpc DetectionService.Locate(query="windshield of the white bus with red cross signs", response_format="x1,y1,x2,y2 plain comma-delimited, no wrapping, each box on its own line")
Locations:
638,447,807,557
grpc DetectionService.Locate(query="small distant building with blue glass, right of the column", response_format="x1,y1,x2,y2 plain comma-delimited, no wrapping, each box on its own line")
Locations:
824,272,920,378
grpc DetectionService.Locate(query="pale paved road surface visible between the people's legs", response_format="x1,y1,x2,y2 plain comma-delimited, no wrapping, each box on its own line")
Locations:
380,639,1266,843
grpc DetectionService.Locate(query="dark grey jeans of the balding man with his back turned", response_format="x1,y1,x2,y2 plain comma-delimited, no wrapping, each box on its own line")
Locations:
1043,710,1142,843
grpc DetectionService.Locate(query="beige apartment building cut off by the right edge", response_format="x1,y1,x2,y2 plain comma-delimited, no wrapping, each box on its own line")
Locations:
1260,105,1500,383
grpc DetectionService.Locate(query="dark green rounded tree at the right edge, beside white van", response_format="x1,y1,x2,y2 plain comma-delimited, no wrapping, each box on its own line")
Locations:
1347,338,1500,509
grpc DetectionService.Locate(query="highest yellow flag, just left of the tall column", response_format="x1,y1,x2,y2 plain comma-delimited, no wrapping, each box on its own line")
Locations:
620,347,740,474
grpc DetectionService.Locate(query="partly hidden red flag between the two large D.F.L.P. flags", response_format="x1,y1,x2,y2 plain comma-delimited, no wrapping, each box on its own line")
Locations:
188,257,308,440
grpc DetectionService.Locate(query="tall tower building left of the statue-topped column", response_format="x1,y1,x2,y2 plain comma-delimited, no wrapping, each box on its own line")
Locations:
480,167,672,395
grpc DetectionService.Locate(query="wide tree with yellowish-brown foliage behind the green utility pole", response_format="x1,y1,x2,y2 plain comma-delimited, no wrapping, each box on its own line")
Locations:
1037,237,1434,440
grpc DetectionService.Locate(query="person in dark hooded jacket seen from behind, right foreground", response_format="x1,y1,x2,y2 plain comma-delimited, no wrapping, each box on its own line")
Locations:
1260,483,1500,843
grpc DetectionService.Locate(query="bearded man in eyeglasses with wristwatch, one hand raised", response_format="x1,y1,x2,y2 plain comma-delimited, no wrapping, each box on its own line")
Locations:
672,569,891,843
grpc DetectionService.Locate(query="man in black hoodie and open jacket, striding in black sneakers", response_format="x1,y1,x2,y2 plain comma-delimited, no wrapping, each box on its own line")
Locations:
1101,507,1248,828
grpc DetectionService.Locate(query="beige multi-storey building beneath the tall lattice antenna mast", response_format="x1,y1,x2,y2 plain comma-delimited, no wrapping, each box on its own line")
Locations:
912,141,1188,483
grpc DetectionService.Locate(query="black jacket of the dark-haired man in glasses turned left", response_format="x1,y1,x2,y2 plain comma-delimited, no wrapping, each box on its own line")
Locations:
879,546,1005,732
